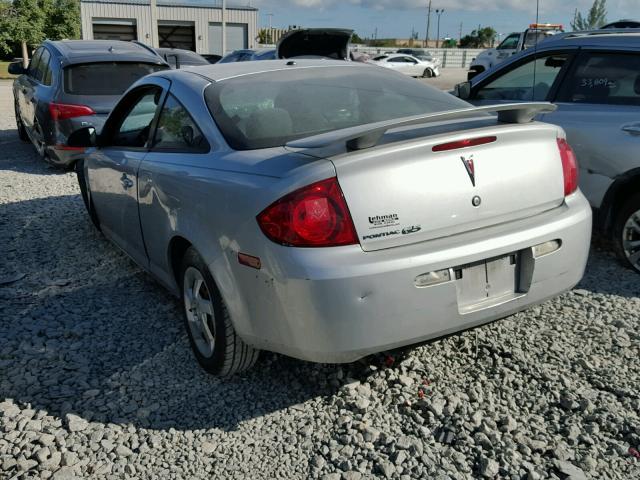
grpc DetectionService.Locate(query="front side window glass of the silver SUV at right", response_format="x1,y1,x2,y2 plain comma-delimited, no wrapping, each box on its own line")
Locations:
475,54,568,101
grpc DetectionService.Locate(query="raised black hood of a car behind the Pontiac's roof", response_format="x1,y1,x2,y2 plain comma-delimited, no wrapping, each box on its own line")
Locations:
276,28,353,60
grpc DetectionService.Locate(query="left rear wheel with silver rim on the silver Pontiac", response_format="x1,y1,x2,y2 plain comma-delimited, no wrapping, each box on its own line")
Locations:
180,247,260,377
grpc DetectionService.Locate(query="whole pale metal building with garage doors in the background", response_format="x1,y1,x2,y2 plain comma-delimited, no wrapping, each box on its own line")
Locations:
80,0,258,55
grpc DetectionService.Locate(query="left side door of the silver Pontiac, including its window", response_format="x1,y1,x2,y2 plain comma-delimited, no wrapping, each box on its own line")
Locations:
88,78,169,267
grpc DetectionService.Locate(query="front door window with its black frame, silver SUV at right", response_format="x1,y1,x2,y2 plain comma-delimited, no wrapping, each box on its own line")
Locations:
469,51,574,105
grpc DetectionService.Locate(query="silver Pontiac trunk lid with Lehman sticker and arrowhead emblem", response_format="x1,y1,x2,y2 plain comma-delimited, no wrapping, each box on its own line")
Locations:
331,123,564,251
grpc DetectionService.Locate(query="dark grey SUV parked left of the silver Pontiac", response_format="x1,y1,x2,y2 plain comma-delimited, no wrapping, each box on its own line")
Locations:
9,40,169,167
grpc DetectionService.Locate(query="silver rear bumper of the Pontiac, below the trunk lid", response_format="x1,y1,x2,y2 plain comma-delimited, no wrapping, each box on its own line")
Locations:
221,192,591,362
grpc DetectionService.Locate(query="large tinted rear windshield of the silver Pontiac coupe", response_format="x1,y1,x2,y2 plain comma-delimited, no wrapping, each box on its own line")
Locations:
205,66,469,150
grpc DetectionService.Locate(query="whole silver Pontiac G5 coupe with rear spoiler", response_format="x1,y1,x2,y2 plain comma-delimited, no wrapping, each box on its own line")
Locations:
69,60,591,375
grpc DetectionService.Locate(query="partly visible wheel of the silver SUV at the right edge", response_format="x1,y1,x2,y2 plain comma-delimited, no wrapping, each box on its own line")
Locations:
613,194,640,273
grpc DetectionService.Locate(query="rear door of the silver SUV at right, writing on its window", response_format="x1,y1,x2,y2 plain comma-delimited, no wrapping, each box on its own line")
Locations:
542,50,640,207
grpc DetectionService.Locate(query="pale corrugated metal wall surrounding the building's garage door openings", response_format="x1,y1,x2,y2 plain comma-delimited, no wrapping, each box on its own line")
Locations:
80,1,258,53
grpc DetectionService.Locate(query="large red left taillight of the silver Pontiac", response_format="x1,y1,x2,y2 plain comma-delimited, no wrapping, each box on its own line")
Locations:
257,177,358,247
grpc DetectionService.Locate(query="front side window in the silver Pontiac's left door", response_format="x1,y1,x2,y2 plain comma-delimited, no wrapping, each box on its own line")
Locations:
110,87,162,148
